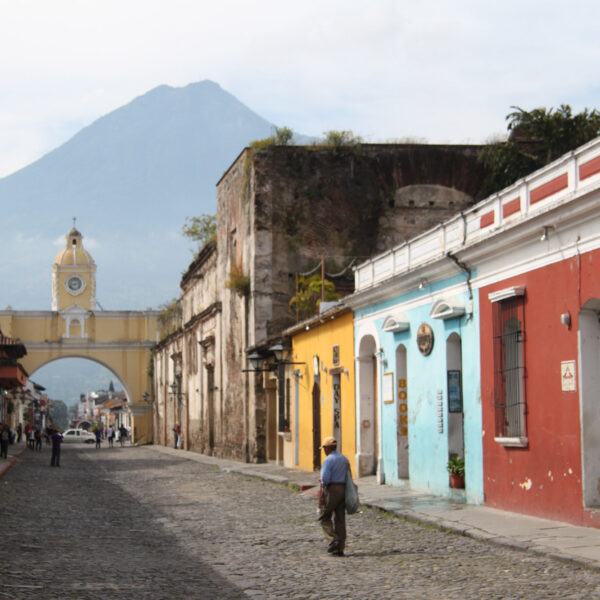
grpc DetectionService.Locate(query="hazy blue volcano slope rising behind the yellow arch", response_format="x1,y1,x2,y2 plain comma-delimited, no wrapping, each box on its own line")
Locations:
0,81,284,309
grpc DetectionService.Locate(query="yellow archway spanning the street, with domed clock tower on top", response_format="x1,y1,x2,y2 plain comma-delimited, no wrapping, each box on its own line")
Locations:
0,228,159,444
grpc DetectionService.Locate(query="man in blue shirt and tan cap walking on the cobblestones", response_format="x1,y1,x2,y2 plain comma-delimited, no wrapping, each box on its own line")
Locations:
319,437,350,556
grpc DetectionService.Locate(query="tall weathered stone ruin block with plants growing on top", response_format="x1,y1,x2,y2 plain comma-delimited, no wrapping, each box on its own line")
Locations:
177,145,485,462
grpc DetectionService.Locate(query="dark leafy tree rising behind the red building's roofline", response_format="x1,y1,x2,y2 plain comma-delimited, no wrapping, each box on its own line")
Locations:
479,104,600,194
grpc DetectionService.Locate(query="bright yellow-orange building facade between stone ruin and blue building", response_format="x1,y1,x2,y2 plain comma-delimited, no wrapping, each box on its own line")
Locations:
285,305,356,473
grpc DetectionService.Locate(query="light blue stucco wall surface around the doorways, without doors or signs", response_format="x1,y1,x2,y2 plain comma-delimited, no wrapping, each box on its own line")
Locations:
355,276,483,503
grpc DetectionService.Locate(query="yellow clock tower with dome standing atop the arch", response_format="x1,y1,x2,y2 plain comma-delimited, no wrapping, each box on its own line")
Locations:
52,227,96,311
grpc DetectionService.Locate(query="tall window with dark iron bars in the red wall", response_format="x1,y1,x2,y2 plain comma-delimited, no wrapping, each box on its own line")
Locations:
493,296,527,438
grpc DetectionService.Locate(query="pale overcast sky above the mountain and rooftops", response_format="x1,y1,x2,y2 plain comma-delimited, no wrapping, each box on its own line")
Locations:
0,0,600,176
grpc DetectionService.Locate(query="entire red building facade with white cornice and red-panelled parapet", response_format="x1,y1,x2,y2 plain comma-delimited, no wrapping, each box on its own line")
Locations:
478,140,600,527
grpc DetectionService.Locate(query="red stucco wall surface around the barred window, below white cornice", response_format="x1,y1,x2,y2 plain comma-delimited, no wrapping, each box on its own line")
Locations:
480,250,600,526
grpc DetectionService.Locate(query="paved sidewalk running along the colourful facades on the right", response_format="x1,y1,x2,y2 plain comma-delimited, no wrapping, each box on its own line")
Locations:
147,446,600,569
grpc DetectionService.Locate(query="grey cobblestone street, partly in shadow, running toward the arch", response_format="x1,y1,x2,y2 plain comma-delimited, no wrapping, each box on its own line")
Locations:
0,447,600,600
